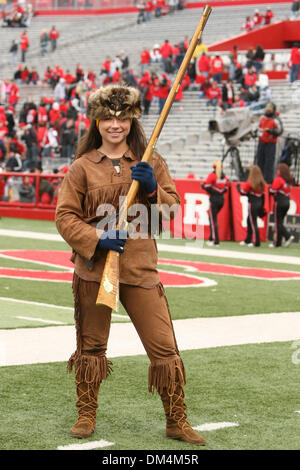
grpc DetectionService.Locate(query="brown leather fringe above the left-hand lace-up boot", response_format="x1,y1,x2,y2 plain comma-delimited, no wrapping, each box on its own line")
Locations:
68,352,113,385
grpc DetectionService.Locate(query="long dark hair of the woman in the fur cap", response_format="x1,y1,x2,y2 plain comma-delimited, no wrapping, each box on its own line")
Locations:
75,118,147,160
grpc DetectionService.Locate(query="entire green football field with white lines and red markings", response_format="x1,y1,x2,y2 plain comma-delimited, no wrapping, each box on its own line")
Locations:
0,218,300,451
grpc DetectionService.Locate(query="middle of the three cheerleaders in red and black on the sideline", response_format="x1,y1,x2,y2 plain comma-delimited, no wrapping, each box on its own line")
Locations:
237,165,265,246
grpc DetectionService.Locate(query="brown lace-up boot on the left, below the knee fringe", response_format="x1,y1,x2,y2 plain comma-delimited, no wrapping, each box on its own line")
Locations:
70,382,100,439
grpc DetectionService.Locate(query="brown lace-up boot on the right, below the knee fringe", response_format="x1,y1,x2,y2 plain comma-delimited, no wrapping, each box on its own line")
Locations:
161,383,206,446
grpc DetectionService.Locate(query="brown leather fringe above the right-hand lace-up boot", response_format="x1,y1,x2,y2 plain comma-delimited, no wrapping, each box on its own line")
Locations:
148,357,186,395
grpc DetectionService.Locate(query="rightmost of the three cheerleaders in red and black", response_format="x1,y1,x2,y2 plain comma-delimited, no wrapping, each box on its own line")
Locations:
269,163,295,248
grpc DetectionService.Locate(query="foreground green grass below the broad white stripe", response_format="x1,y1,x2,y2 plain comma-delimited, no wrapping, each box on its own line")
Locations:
0,342,300,450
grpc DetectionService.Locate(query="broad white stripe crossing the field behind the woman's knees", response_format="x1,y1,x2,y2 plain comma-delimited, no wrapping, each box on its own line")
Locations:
0,312,300,366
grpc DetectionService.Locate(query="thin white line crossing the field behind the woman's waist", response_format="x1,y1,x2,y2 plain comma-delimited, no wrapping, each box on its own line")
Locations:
0,229,300,265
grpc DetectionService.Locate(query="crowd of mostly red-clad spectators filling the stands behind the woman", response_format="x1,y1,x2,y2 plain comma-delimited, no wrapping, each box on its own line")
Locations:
0,1,300,206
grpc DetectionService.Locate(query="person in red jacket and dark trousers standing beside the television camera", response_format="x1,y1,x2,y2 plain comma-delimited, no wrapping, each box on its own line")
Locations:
256,102,283,184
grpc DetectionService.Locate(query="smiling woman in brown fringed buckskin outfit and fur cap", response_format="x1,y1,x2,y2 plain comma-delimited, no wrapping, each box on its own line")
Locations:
56,85,205,445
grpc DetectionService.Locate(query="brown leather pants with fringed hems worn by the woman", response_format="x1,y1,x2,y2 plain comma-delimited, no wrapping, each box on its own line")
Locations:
68,273,185,394
